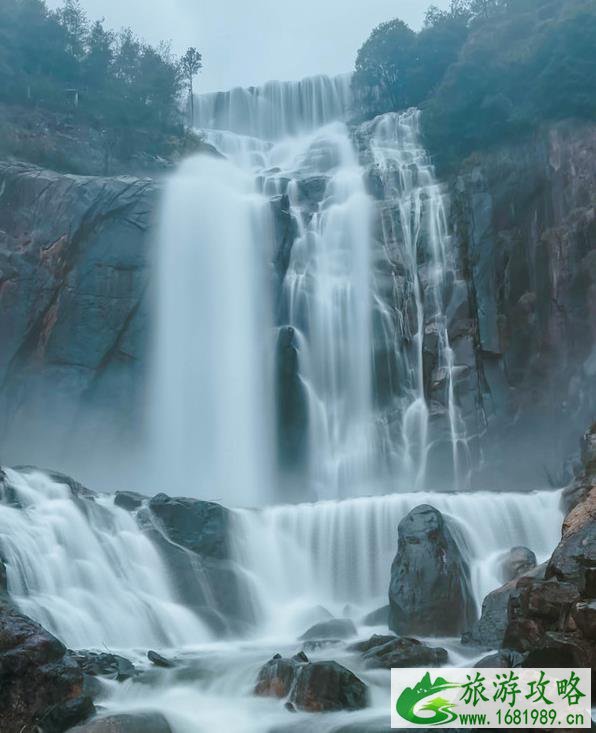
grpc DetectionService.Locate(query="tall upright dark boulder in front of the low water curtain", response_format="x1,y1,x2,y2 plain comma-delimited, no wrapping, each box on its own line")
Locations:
389,504,476,636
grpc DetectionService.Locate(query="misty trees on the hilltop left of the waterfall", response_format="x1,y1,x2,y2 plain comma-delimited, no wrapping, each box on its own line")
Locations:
0,0,200,132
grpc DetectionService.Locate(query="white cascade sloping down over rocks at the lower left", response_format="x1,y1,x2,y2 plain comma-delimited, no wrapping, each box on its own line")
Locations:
0,469,209,649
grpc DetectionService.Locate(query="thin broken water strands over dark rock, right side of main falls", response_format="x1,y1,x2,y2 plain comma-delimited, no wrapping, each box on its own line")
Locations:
369,110,468,490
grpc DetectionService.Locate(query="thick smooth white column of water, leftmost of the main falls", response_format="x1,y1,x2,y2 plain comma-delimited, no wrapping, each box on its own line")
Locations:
151,151,272,505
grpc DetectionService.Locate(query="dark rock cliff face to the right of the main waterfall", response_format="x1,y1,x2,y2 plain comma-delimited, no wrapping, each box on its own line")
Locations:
452,123,596,487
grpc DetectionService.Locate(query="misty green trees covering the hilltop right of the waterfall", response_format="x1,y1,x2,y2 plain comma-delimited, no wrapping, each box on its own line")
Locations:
353,0,596,163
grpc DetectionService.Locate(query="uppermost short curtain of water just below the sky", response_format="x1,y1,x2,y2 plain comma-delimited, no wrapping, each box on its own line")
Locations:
195,74,352,140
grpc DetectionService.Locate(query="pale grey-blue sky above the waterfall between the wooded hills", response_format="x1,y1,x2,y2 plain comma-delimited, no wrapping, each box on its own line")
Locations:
48,0,448,91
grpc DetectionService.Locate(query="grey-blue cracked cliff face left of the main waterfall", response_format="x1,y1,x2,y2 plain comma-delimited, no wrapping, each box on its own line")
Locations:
0,162,156,486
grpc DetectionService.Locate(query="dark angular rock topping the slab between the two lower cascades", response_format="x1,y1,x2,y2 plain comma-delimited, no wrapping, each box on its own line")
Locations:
149,494,229,560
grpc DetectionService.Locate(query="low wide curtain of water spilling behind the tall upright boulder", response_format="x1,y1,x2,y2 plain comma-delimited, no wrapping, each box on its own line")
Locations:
233,491,562,633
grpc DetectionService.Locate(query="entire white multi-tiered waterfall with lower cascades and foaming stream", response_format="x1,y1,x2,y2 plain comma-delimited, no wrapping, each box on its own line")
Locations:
0,76,572,733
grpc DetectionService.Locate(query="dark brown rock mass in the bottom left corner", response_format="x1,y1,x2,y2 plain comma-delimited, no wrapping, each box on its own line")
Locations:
0,600,93,733
